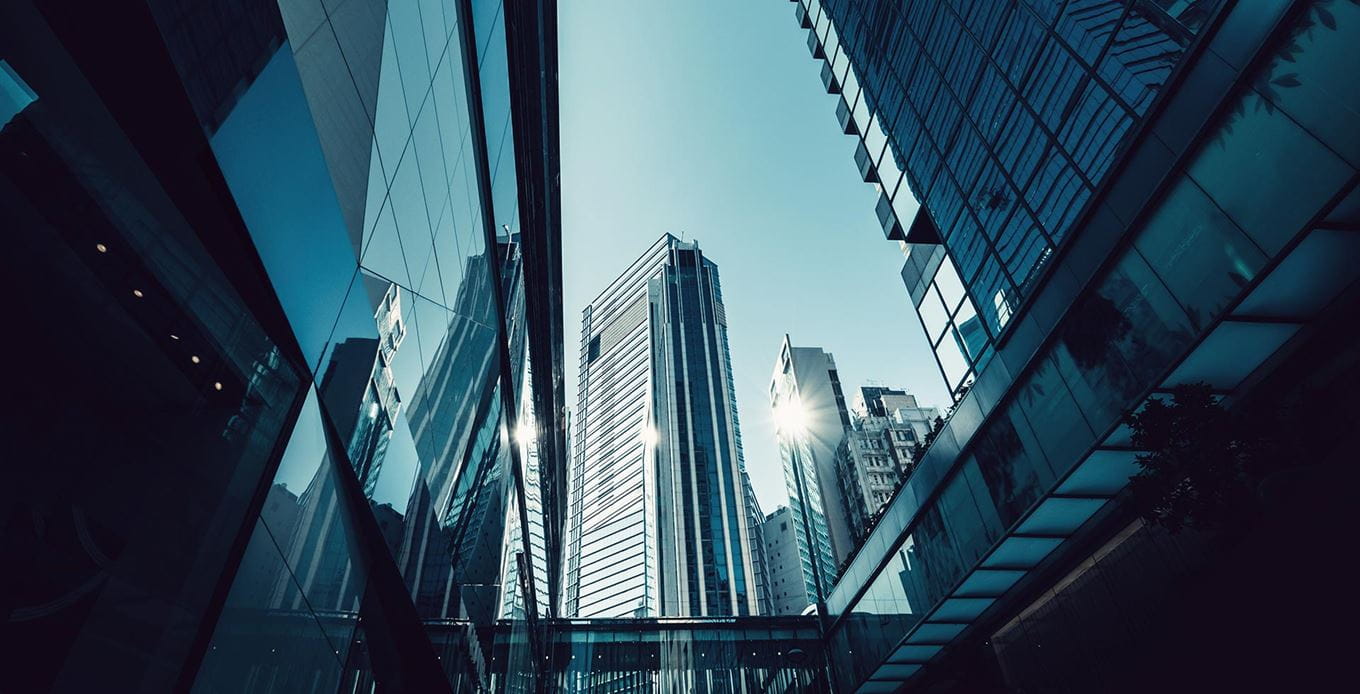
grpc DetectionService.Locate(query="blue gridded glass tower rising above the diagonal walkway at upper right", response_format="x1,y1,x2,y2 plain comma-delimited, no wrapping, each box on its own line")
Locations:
798,0,1219,391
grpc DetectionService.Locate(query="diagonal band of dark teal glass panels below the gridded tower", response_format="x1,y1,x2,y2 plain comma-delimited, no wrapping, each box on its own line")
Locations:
831,4,1360,686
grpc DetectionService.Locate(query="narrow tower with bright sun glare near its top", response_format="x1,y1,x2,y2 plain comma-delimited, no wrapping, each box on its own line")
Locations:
770,335,854,600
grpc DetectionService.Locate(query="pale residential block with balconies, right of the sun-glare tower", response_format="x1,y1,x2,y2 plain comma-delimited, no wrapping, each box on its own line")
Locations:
836,385,940,543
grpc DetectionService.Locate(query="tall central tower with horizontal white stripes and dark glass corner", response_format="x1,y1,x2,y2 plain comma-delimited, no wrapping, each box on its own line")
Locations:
567,234,763,616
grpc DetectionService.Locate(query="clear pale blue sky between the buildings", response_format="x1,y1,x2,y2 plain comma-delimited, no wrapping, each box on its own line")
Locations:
558,0,948,513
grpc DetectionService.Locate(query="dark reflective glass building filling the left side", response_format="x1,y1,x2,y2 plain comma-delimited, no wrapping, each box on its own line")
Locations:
0,0,566,693
